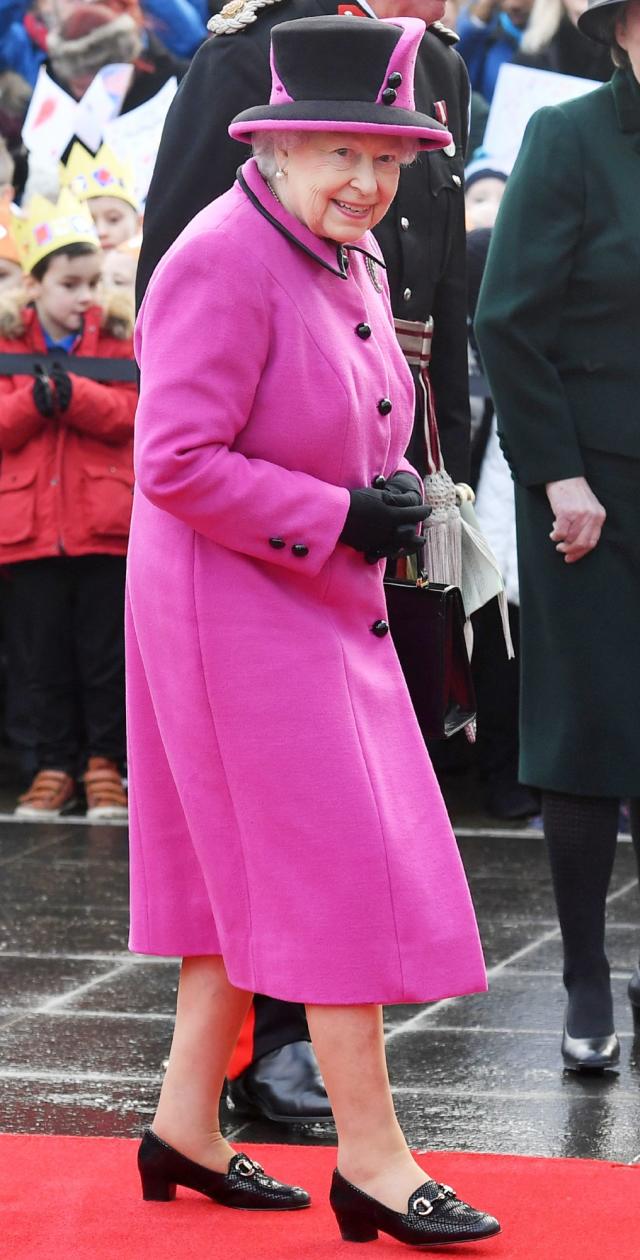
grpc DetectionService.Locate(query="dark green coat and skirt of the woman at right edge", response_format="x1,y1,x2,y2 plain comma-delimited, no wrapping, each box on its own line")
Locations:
475,71,640,796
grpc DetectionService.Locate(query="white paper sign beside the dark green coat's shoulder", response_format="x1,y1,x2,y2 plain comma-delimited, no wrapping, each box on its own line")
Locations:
483,66,601,171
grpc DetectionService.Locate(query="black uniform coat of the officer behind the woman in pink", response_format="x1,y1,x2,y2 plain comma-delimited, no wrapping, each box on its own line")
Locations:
137,0,470,480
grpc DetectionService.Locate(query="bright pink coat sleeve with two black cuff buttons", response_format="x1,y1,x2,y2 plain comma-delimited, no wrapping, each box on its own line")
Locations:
134,232,349,577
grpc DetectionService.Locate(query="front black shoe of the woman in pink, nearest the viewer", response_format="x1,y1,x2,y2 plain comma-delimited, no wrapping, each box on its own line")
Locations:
329,1168,500,1247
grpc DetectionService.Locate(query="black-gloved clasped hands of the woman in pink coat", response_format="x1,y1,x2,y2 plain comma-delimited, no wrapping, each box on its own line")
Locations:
340,486,431,564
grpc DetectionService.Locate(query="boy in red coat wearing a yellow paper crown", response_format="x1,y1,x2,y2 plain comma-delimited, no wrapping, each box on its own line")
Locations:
0,192,137,822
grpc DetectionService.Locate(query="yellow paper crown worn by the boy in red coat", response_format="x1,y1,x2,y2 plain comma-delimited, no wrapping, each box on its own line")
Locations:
14,188,100,271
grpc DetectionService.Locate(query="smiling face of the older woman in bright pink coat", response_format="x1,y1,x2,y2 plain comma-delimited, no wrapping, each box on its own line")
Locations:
273,131,404,244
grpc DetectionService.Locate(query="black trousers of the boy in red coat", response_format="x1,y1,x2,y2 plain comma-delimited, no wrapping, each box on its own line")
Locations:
6,556,126,775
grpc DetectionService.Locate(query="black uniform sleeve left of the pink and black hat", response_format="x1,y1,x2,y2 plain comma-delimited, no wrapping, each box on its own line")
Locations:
136,35,271,305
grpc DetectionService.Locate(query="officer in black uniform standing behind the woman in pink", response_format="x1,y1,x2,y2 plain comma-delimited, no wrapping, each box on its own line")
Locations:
137,0,470,1123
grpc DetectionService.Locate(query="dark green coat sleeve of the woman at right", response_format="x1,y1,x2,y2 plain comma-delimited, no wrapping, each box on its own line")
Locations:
475,106,585,485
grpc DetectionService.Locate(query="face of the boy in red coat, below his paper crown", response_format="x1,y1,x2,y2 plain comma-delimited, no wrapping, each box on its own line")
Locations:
26,249,102,340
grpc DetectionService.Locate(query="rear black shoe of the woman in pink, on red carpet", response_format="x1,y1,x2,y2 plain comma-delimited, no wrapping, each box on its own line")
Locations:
137,1129,311,1212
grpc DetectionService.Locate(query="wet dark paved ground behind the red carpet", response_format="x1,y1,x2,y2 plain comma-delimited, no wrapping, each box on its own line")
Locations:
0,803,640,1163
